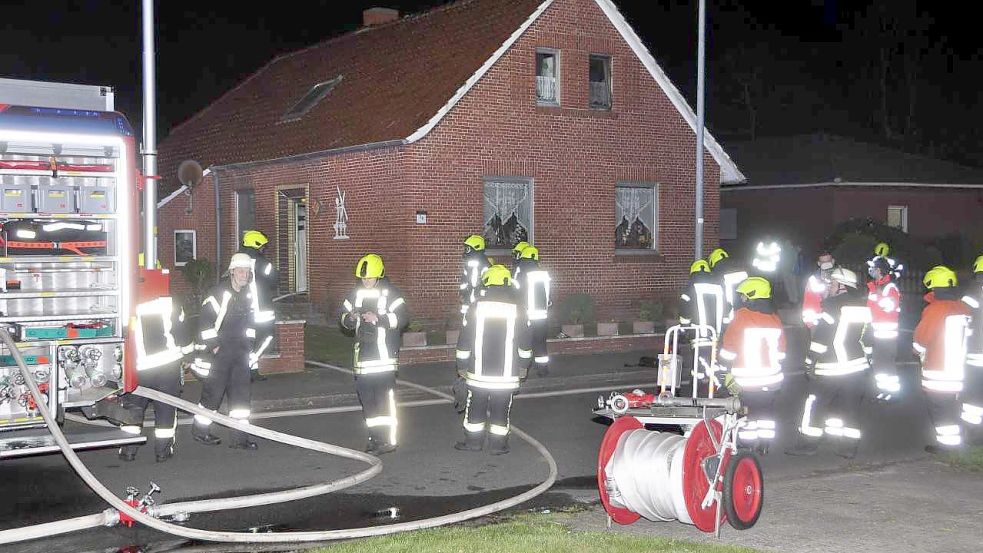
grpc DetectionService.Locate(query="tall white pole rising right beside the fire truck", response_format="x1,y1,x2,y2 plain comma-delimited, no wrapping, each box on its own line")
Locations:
142,0,157,269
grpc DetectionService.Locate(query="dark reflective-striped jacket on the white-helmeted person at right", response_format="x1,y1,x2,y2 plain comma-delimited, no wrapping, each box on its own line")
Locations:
806,294,871,376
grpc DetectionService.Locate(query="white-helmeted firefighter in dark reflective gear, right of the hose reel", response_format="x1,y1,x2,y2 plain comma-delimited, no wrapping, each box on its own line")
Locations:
786,267,871,459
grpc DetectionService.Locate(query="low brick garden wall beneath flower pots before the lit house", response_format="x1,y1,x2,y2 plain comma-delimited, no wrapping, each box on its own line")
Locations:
399,333,665,365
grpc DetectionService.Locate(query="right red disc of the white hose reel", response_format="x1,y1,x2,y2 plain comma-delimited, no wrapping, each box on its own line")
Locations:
683,420,727,532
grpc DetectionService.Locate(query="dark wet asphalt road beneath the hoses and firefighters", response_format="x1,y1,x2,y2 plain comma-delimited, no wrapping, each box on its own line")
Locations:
0,332,968,553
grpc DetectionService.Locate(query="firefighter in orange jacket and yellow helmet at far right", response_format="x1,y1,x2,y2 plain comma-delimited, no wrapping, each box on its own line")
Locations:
912,265,971,452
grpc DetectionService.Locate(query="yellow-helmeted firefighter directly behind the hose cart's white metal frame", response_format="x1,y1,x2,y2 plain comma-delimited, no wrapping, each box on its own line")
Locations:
679,259,726,392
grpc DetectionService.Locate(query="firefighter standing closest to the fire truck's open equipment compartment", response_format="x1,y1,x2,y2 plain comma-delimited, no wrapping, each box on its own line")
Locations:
119,280,194,463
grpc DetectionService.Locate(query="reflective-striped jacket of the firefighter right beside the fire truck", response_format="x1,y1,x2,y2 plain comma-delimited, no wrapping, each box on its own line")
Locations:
133,296,194,371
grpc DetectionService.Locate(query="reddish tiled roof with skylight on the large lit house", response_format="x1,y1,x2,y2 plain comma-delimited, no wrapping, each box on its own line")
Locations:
160,0,542,197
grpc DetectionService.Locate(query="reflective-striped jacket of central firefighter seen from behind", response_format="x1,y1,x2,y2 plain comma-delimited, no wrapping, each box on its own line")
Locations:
457,287,532,390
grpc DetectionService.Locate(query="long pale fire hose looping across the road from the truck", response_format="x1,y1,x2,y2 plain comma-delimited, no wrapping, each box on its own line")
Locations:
0,329,557,544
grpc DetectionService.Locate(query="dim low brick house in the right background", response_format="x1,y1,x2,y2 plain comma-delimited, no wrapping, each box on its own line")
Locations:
720,134,983,255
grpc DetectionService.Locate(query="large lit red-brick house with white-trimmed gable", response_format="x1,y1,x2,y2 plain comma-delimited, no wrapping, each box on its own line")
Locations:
158,0,743,332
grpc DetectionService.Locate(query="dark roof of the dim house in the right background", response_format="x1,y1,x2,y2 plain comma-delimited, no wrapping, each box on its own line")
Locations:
727,133,983,188
